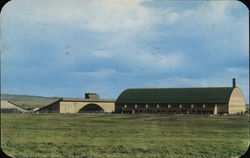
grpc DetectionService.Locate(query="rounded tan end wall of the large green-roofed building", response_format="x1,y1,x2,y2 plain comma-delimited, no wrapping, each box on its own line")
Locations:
228,88,246,114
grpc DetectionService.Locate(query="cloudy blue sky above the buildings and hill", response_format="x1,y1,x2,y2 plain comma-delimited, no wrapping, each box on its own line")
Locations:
0,0,249,103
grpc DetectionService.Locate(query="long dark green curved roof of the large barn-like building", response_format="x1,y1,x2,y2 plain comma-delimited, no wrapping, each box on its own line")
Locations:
116,87,233,104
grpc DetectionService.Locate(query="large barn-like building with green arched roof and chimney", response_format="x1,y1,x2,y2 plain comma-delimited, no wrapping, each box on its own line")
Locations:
115,79,245,114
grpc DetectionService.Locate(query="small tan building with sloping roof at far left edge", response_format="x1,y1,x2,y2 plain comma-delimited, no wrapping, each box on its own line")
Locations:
1,100,28,113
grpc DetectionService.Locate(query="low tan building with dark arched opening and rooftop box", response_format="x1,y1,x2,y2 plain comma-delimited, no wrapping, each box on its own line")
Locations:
36,93,115,113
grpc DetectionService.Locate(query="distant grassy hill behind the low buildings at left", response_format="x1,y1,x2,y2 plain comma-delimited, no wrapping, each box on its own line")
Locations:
1,94,59,109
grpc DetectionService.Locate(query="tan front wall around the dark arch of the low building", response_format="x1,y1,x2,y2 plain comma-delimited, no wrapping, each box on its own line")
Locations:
60,101,115,113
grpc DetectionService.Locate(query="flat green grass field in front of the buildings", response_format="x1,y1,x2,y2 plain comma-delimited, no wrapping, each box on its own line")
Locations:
1,114,249,158
